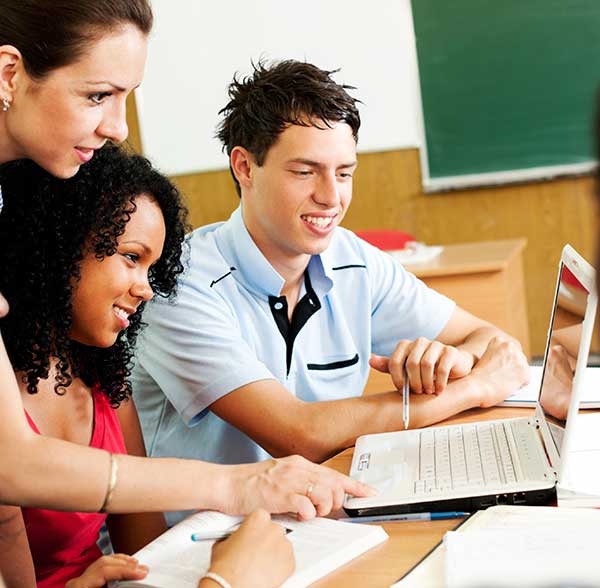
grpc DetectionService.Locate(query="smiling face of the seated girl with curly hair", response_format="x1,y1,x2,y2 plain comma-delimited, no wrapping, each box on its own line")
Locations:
69,194,165,347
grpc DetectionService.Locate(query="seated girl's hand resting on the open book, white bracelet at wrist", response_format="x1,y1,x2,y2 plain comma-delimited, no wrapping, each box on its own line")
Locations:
199,510,295,588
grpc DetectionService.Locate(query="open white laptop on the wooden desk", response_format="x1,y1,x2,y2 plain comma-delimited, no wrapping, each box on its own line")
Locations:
344,245,597,516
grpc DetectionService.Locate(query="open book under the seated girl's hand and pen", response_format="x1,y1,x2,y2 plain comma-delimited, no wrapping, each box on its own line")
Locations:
119,511,388,588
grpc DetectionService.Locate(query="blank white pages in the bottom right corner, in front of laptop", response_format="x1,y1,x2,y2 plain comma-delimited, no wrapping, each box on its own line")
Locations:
391,506,600,588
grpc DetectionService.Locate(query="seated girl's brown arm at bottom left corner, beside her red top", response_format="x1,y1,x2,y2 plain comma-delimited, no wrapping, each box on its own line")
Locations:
0,506,36,588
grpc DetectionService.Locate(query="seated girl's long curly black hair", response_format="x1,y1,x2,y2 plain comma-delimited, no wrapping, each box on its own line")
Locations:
0,145,188,407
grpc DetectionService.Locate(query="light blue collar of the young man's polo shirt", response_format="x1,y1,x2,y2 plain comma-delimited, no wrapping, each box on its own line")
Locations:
216,205,333,298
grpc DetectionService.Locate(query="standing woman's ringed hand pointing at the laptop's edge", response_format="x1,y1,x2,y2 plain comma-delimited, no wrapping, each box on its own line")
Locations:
218,455,375,520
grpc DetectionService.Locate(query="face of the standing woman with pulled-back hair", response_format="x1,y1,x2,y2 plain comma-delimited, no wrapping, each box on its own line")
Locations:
5,25,147,178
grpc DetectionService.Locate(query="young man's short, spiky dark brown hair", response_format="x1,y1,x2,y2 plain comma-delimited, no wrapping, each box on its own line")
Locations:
217,60,360,194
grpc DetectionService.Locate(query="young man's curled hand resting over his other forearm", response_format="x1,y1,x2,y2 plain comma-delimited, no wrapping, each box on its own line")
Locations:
369,337,475,394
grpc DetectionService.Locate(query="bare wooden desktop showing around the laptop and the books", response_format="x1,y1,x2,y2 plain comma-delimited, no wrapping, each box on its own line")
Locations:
313,408,533,588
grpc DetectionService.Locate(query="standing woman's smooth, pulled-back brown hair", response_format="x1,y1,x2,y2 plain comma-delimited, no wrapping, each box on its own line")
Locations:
0,0,153,80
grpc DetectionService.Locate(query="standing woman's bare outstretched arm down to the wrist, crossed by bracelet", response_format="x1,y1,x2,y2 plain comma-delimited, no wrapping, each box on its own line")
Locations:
0,337,238,513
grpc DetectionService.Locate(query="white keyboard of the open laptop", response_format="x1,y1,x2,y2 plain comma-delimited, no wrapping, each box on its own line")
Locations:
414,420,544,494
